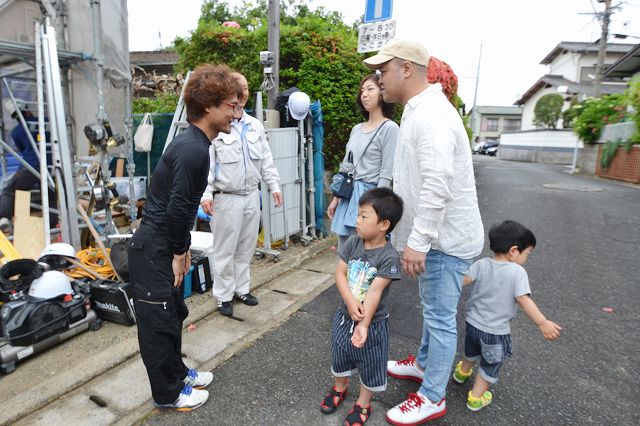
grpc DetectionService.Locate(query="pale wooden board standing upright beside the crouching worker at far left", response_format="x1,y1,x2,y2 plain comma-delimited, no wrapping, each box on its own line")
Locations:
13,191,44,260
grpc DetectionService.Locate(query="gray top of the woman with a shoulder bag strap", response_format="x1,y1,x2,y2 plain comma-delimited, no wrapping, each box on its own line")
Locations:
344,120,399,188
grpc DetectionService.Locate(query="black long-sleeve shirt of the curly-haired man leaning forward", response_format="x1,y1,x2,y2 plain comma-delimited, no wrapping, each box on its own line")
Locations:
142,125,211,254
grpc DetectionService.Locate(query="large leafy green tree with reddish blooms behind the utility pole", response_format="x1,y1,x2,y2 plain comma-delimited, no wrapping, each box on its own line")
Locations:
175,0,468,168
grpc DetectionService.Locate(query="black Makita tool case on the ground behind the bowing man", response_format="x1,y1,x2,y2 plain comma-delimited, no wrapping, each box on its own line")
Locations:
89,280,136,325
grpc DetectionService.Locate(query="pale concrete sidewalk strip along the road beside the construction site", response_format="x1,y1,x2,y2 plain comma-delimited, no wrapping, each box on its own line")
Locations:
0,238,335,426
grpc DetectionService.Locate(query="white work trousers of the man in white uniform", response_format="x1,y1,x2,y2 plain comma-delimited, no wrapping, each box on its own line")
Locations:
211,190,260,302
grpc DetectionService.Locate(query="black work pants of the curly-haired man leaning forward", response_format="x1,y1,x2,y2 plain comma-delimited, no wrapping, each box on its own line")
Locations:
129,222,189,404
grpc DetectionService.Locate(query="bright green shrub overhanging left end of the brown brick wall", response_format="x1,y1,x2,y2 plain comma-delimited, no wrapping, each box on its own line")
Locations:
573,94,626,143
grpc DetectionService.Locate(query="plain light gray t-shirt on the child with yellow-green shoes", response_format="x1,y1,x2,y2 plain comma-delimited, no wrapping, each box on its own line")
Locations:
466,257,531,335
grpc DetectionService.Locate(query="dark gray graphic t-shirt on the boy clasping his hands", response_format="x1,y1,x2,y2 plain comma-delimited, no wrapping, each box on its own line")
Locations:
339,235,400,323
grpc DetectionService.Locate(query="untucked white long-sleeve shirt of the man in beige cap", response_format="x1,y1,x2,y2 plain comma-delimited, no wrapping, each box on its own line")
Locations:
392,83,484,259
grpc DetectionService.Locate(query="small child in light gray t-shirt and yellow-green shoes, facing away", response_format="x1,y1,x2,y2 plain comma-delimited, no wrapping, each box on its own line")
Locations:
453,220,561,411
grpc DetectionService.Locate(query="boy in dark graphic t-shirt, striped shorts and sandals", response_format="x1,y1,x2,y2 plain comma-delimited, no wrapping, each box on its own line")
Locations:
320,188,403,425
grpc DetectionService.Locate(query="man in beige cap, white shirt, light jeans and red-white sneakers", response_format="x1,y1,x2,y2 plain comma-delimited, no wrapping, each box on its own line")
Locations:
364,40,484,425
